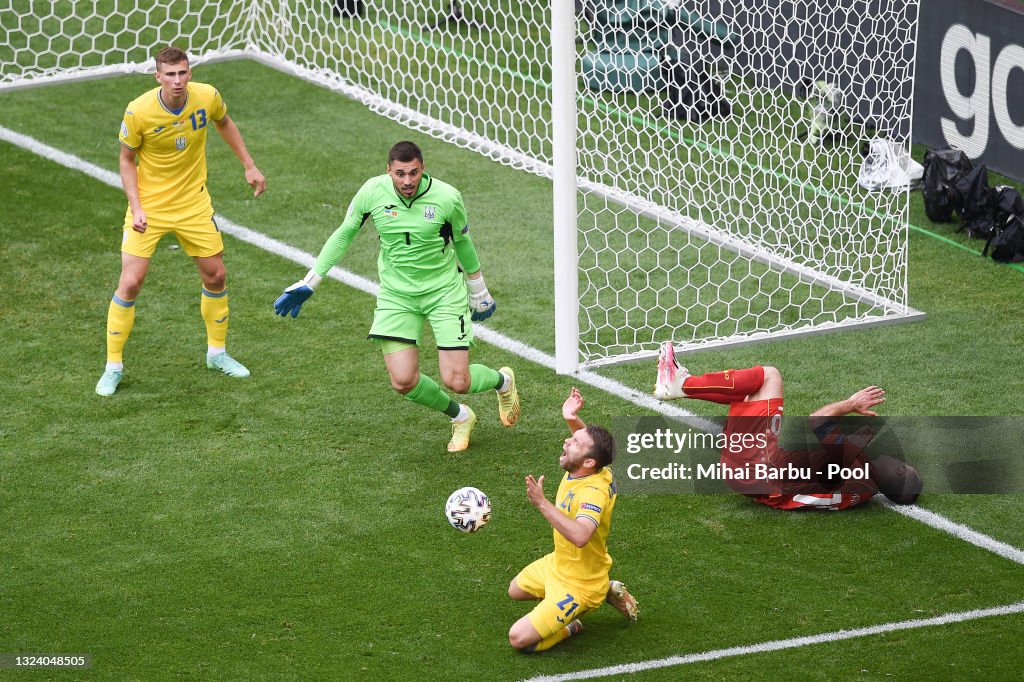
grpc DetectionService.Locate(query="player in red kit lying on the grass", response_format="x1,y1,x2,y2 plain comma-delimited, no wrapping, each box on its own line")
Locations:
654,341,923,509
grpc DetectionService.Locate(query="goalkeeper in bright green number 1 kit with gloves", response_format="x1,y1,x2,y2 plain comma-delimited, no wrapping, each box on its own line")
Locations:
273,142,519,453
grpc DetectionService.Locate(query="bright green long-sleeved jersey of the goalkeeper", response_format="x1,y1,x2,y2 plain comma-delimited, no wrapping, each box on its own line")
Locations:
313,174,480,296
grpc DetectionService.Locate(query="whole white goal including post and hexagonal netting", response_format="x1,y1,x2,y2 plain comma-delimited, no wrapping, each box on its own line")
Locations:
0,0,924,373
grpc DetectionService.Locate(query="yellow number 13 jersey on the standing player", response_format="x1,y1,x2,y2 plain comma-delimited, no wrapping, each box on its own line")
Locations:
120,83,227,220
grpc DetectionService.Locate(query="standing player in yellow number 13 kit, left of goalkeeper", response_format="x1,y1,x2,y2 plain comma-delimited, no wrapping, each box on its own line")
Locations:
96,47,266,395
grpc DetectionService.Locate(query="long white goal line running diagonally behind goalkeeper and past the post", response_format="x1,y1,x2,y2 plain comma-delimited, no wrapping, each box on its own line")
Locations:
6,126,1024,564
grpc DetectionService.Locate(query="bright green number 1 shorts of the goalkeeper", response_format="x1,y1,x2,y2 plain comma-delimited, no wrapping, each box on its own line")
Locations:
369,283,473,350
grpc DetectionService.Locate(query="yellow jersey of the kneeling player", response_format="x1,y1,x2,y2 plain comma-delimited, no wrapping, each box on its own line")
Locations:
555,467,615,590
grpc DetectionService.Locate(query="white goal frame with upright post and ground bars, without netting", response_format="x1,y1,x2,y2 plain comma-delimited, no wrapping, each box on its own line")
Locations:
0,0,925,374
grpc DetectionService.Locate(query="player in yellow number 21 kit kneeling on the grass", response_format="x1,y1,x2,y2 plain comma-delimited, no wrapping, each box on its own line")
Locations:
509,388,637,652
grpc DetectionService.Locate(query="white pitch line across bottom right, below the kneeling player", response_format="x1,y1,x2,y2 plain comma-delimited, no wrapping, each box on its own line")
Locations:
525,601,1024,682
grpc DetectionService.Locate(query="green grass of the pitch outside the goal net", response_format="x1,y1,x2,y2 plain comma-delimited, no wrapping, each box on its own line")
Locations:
0,62,1024,680
